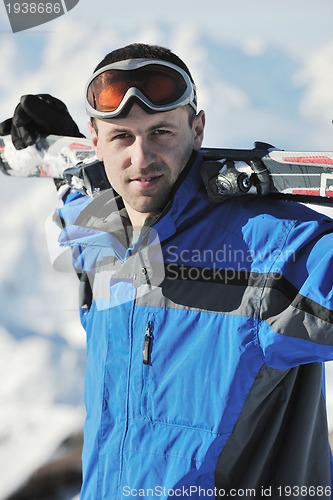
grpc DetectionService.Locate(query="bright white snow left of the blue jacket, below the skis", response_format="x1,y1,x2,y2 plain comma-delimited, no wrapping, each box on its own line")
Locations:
0,176,85,499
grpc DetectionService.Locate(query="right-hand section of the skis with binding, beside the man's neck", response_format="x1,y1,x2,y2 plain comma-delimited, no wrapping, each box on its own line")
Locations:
201,142,333,205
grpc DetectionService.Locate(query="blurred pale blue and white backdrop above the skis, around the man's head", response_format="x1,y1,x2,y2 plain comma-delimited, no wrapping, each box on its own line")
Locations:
0,0,333,150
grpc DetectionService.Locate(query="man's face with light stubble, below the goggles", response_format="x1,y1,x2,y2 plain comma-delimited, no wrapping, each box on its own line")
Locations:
91,104,204,225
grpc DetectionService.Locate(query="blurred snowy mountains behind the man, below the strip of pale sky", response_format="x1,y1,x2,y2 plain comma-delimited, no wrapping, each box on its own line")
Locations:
0,17,333,500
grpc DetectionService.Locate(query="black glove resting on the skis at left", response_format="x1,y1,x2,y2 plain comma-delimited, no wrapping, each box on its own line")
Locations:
0,94,84,149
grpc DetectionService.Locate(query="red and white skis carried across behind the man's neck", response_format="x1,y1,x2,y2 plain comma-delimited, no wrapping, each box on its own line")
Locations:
0,135,333,205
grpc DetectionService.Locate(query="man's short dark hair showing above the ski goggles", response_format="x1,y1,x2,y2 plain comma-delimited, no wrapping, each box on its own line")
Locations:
91,43,195,131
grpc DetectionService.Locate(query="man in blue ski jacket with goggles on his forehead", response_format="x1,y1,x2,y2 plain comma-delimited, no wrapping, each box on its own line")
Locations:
0,44,333,500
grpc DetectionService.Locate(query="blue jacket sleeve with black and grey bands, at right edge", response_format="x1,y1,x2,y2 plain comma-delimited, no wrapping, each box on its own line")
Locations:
258,217,333,369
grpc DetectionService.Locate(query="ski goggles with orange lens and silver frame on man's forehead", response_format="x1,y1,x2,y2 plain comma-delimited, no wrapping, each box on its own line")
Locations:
85,59,197,119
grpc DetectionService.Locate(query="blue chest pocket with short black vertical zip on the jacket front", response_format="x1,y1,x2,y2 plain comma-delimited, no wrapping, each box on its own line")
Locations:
132,309,258,432
